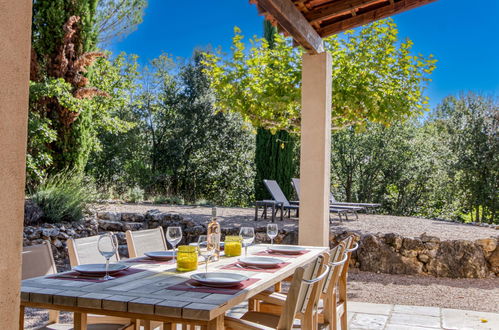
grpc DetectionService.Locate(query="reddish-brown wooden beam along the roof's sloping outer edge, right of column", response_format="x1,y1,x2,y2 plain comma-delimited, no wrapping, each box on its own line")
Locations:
318,0,437,38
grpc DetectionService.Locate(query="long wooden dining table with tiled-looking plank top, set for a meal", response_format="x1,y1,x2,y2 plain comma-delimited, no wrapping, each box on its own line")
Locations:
21,244,327,330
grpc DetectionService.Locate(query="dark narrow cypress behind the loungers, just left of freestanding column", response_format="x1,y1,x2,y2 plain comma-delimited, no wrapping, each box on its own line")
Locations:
255,20,296,200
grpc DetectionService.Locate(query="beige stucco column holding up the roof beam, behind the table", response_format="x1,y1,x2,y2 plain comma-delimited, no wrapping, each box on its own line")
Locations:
298,52,332,246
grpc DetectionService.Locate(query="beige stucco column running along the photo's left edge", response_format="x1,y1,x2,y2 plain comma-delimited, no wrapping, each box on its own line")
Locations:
0,0,31,329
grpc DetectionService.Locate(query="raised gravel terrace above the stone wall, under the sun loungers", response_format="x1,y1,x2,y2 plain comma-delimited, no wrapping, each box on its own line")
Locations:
95,204,499,240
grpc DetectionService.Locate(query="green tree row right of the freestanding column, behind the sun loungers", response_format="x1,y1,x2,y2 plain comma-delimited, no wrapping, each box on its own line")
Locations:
331,93,499,222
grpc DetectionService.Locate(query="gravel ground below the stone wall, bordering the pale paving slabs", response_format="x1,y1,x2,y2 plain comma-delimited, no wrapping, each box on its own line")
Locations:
25,269,499,329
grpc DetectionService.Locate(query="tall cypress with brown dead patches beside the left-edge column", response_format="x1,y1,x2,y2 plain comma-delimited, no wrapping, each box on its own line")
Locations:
30,0,103,172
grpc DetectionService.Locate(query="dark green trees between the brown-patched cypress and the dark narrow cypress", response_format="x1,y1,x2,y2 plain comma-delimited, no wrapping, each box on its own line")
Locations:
88,52,254,205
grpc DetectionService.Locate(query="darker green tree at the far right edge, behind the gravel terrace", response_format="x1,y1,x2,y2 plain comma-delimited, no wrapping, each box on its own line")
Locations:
434,93,499,222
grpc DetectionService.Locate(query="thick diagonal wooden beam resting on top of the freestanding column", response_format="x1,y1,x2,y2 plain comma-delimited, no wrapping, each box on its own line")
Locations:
258,0,324,54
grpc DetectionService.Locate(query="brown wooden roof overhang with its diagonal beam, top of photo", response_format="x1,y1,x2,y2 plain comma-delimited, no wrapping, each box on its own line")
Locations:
254,0,436,54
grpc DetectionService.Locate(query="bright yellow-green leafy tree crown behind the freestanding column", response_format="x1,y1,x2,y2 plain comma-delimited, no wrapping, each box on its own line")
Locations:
203,19,436,131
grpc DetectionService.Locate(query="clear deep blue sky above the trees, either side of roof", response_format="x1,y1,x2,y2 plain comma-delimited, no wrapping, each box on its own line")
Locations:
111,0,499,106
